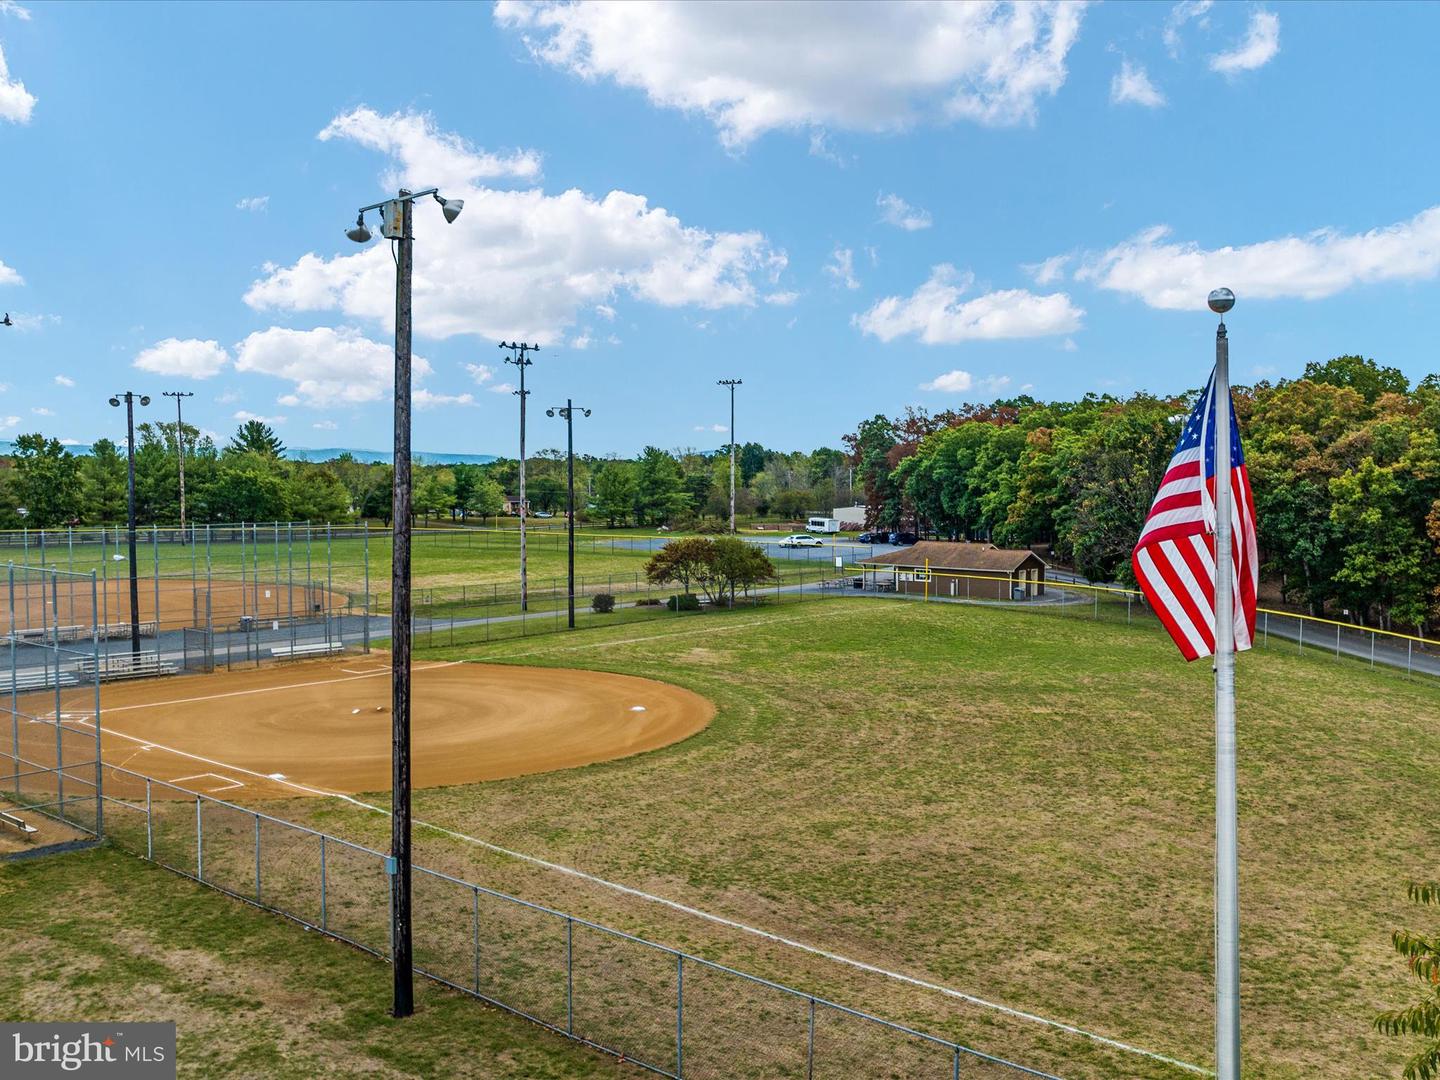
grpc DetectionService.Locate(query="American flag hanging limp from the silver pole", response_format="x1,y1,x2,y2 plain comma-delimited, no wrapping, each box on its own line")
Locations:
1130,372,1260,660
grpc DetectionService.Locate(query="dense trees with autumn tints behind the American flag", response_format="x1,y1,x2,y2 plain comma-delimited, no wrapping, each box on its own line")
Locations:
845,356,1440,628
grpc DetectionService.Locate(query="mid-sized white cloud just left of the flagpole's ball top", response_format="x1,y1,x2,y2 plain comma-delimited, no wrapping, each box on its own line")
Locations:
852,264,1084,346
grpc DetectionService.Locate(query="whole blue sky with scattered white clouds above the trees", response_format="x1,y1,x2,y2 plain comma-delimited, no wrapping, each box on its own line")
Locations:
0,0,1440,454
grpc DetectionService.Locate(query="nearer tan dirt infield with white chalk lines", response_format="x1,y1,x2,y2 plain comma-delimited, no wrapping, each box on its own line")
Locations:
80,654,714,799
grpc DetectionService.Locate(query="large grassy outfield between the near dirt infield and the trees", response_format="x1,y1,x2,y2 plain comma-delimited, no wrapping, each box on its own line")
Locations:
270,599,1440,1079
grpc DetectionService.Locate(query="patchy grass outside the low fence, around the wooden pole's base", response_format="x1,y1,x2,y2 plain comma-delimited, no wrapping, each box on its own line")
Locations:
0,850,639,1080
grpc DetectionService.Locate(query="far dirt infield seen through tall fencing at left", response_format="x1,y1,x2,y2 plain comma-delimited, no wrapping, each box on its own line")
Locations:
0,577,348,634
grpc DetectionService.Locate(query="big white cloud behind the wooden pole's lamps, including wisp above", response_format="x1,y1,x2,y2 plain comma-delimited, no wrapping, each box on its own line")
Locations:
245,109,786,344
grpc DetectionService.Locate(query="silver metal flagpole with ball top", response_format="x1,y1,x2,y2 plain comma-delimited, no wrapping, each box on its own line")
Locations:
1210,289,1240,1080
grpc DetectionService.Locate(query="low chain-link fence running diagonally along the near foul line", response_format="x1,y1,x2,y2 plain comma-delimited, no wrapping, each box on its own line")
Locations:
92,766,1056,1080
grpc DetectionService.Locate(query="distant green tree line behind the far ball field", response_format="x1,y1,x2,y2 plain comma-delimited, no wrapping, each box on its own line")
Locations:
0,420,851,531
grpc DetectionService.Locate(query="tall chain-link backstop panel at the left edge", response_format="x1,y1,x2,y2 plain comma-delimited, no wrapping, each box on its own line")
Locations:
0,564,104,837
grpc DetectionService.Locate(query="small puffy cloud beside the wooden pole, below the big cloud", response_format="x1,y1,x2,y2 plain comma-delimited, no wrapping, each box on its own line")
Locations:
235,327,431,409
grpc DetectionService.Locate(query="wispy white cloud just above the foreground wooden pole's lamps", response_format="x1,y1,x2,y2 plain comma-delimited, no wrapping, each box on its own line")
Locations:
318,105,540,188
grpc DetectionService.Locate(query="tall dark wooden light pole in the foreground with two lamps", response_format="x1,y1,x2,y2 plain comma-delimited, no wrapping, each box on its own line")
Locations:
346,187,465,1017
